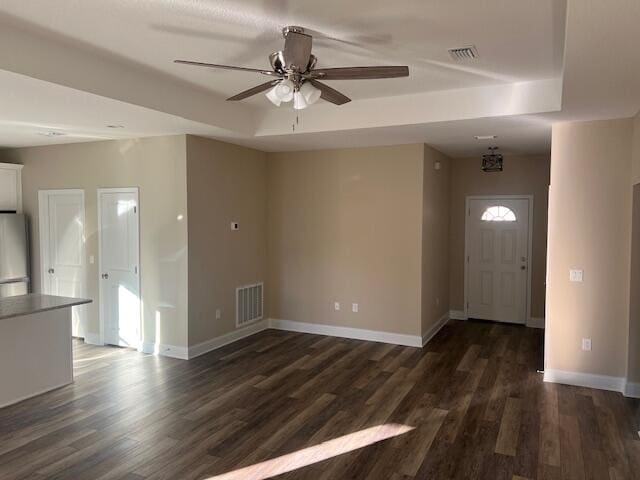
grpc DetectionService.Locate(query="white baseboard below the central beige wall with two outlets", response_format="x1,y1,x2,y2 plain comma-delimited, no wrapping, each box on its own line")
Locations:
269,318,422,347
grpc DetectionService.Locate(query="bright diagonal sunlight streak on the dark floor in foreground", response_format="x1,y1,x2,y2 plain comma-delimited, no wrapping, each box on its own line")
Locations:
207,423,414,480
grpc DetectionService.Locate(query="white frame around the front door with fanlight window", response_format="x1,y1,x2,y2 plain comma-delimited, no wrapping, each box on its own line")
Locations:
464,195,534,326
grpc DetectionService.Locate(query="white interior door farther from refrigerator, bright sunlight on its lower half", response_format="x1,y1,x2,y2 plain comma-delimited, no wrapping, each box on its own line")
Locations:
98,188,141,348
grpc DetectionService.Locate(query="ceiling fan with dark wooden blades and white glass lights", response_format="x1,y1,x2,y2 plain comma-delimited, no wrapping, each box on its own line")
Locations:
174,26,409,110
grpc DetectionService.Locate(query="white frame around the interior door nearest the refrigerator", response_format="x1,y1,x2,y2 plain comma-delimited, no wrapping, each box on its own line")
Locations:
38,188,88,334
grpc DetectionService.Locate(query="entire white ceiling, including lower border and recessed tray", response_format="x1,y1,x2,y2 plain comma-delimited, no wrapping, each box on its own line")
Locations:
0,0,640,157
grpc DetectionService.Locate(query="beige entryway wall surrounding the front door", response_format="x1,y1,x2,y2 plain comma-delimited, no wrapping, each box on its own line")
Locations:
449,155,550,318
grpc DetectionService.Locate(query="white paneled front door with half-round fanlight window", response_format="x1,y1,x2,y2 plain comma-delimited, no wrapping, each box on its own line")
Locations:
465,197,530,324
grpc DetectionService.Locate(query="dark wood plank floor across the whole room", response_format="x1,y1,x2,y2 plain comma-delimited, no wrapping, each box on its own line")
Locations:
0,321,640,480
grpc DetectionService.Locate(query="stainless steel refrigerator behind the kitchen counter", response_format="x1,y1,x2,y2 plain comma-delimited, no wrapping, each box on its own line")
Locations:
0,213,29,297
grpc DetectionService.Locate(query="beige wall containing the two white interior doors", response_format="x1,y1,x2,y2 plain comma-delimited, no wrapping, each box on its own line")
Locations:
0,136,188,347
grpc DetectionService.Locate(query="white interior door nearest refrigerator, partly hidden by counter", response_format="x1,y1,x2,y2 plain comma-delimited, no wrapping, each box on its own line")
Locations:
38,190,87,337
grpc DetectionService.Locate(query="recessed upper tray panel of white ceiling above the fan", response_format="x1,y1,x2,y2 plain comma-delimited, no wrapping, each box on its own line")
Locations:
0,0,564,103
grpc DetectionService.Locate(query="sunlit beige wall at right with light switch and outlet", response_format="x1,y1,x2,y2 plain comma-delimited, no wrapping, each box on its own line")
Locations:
546,120,633,377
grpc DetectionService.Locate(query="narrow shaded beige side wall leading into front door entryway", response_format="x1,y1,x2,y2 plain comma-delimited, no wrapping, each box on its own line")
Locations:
422,145,451,335
